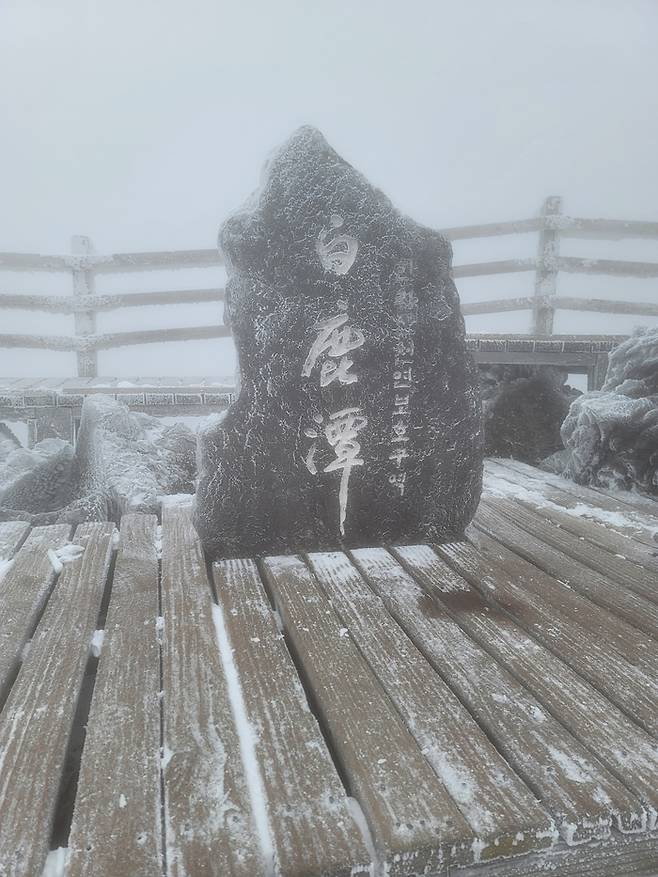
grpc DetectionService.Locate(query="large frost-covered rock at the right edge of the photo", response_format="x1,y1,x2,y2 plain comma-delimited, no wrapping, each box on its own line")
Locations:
560,329,658,495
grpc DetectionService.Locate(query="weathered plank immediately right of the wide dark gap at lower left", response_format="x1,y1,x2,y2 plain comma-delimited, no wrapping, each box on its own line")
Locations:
67,515,162,877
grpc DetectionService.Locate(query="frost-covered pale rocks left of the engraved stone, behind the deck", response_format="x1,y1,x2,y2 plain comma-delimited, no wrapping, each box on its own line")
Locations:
0,395,196,524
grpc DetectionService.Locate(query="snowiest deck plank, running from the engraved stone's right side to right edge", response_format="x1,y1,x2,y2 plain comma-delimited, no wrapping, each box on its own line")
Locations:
486,459,658,548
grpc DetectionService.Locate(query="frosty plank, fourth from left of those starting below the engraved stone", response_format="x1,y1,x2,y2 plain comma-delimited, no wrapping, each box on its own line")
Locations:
352,548,645,845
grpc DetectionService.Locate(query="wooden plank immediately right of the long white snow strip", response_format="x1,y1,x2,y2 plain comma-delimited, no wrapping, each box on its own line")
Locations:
213,560,370,877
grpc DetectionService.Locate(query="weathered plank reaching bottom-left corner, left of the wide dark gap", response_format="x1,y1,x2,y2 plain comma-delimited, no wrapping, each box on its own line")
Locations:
0,524,114,877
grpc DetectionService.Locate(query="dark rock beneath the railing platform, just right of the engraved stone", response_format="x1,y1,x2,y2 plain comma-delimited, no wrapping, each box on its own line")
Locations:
480,365,578,465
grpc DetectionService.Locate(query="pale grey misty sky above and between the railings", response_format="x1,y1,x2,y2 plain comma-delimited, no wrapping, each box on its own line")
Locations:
0,0,658,377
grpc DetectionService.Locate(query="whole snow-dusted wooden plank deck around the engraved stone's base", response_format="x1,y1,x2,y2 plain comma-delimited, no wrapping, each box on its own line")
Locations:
0,461,658,877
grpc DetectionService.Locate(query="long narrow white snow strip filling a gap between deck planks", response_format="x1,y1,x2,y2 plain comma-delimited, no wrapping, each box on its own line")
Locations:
212,604,275,877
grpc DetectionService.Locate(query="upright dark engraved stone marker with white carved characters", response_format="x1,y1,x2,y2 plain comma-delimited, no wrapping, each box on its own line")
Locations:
196,128,482,557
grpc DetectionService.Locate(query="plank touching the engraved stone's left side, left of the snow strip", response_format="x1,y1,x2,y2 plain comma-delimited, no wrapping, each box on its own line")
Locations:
161,501,265,877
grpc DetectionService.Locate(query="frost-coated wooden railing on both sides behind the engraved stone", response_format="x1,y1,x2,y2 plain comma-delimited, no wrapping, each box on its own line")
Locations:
0,197,658,377
